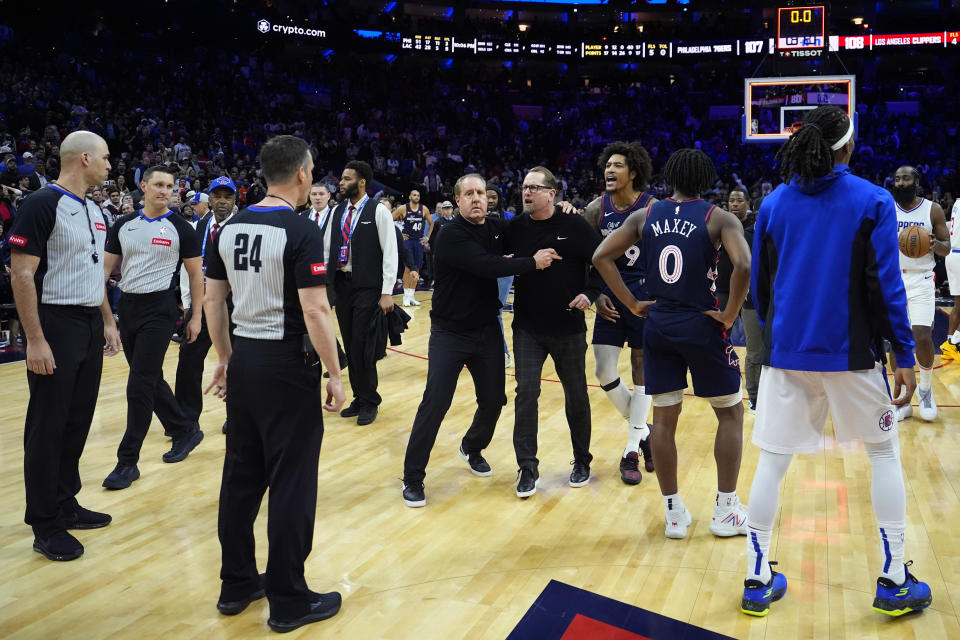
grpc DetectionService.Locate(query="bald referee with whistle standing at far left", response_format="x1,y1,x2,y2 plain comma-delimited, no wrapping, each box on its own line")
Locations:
9,131,120,560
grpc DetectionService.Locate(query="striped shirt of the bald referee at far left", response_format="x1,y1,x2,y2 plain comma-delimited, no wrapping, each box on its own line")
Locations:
8,185,107,307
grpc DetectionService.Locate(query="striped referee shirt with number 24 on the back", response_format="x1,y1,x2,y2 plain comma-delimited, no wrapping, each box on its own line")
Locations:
207,206,327,340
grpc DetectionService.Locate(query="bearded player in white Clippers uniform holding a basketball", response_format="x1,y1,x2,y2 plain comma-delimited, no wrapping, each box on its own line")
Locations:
891,166,950,422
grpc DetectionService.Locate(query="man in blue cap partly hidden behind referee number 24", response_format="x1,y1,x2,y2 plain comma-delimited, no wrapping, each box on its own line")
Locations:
174,176,237,429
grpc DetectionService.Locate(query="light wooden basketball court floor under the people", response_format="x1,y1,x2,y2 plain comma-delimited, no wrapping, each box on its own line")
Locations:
0,294,960,640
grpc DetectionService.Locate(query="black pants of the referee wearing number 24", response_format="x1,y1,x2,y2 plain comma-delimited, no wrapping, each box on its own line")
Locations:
217,336,323,620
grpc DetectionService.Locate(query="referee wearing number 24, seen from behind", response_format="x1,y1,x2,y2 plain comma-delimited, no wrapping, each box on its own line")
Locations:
204,135,344,632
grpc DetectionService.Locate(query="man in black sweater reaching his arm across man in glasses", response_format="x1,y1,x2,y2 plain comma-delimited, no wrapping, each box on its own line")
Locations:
403,173,560,507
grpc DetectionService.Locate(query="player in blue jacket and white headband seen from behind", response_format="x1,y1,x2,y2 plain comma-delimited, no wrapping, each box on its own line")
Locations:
736,106,930,616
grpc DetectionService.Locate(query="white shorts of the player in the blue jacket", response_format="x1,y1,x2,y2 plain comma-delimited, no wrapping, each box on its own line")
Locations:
753,364,897,454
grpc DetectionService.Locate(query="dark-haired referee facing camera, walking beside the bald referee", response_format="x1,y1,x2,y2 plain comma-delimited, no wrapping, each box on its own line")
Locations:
103,166,203,489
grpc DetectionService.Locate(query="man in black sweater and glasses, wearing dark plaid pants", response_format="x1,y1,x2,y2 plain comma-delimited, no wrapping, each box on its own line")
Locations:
506,167,601,498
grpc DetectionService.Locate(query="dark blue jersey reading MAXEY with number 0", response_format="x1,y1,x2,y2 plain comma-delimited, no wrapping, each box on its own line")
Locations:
643,198,718,311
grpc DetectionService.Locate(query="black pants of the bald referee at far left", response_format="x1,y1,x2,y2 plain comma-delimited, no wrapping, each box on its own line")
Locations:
23,304,104,538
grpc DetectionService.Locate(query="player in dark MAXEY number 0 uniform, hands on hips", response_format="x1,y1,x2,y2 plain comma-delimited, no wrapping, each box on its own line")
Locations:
593,149,750,538
